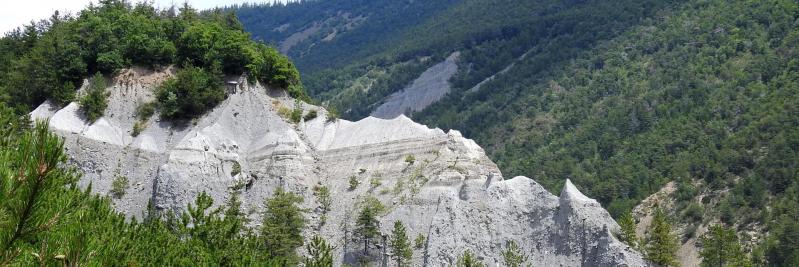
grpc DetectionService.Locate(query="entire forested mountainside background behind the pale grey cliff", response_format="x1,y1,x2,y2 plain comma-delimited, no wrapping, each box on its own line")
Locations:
239,0,799,266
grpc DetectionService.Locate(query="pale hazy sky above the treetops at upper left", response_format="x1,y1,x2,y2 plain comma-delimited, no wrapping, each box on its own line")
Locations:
0,0,282,35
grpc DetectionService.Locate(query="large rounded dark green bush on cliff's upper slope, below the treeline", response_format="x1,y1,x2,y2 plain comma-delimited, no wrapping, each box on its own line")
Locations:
156,67,225,118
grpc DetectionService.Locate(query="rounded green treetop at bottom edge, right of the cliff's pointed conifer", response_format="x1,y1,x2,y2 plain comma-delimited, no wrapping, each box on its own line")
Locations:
699,225,753,267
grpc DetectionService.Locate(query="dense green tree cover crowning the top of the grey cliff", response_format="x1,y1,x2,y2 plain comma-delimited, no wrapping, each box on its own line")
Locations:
0,0,309,118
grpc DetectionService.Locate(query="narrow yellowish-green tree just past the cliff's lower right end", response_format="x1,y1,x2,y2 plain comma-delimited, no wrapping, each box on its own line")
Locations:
645,208,679,266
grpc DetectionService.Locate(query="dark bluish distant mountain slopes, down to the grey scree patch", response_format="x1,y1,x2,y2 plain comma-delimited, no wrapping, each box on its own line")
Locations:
236,0,677,119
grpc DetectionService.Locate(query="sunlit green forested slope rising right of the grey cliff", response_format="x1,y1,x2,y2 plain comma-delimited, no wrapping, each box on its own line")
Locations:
428,1,799,266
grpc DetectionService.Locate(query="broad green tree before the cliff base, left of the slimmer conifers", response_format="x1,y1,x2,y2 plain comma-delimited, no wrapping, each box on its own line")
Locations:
261,188,306,265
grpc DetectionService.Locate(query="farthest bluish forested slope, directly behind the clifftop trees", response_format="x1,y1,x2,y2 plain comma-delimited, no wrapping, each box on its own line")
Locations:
234,0,459,72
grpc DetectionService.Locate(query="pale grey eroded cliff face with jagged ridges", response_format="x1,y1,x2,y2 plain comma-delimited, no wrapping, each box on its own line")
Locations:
31,70,646,266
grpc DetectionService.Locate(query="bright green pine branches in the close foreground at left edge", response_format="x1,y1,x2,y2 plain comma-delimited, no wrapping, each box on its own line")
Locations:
0,122,78,265
